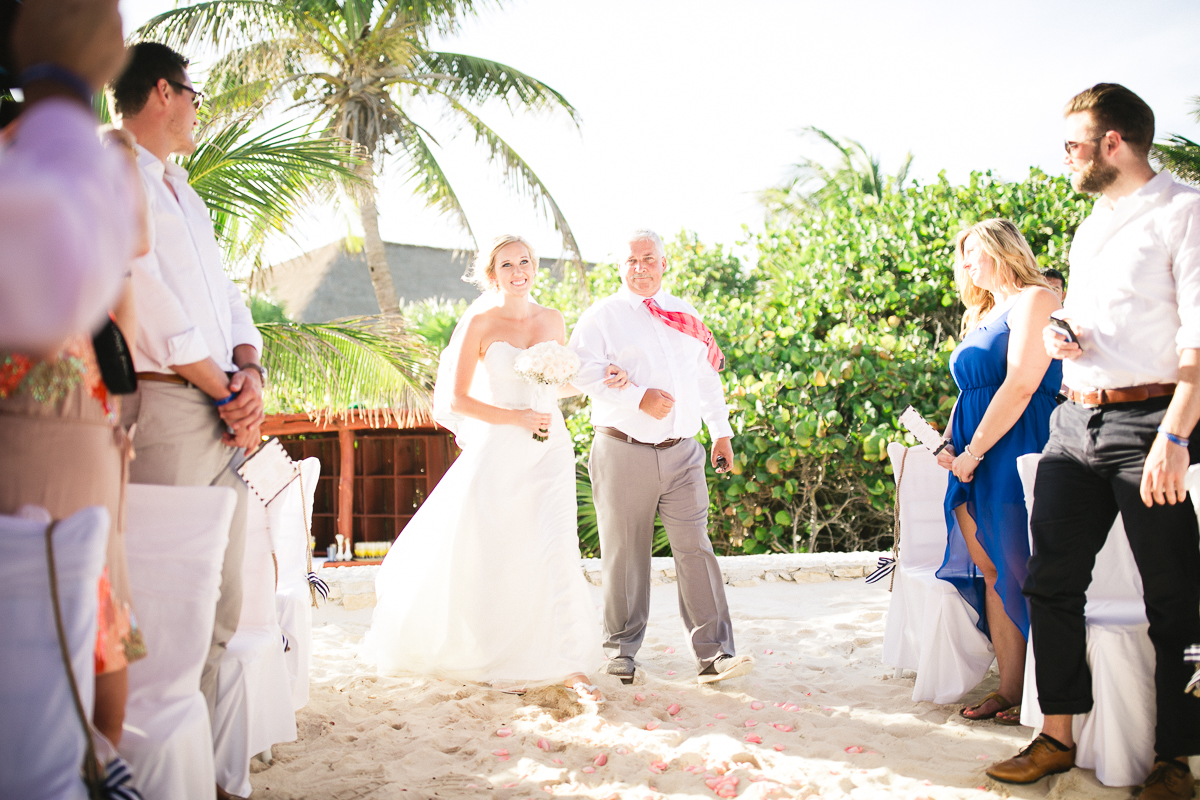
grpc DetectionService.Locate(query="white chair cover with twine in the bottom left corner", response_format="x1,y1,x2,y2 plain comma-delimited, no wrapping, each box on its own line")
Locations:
0,506,108,800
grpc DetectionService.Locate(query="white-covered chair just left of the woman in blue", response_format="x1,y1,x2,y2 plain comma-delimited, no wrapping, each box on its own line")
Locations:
883,441,995,703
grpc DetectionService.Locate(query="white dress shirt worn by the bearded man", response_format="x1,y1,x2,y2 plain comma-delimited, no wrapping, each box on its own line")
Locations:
1062,172,1200,391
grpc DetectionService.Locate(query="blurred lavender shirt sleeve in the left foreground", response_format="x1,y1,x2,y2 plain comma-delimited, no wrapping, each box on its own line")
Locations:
0,98,137,351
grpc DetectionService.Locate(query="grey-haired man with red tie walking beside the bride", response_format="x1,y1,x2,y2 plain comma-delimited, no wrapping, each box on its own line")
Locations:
571,230,754,684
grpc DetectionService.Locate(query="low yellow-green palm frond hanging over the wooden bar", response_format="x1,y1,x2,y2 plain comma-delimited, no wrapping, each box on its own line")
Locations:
258,317,436,425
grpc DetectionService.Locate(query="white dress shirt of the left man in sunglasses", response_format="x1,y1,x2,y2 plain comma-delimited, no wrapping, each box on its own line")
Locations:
133,145,263,373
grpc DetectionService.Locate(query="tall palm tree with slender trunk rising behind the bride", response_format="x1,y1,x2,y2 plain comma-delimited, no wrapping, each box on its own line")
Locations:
138,0,583,313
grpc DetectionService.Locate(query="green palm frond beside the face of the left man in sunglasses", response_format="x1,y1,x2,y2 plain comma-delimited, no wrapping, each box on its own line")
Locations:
181,120,362,262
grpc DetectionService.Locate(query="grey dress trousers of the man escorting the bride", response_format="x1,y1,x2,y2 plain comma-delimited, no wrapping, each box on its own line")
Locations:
588,433,737,670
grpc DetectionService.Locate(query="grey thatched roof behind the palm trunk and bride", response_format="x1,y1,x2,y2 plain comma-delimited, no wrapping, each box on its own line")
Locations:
254,241,571,323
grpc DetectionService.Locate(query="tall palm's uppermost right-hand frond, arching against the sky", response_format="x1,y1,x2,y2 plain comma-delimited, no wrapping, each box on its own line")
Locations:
414,50,580,125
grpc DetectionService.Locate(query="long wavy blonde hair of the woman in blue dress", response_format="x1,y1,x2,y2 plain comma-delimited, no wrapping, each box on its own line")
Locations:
954,218,1050,336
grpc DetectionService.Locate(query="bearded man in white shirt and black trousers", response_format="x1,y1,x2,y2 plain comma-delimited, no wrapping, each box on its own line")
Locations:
988,84,1200,800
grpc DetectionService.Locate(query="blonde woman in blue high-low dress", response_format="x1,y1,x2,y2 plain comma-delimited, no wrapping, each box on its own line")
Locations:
937,219,1062,724
